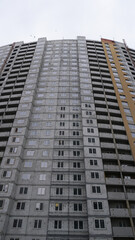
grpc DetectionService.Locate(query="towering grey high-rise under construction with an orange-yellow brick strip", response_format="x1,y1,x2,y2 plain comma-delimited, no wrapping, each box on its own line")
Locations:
0,37,135,240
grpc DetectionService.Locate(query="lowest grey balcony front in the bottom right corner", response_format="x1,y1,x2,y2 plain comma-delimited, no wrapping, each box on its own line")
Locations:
113,227,133,237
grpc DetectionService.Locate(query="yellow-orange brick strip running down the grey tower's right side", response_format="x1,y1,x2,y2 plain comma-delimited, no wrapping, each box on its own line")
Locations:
101,39,135,160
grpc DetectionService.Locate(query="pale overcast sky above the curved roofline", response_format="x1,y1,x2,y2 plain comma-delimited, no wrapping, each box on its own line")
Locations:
0,0,135,48
